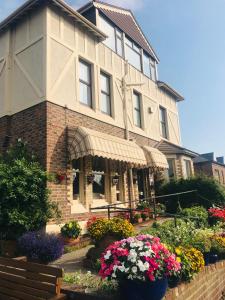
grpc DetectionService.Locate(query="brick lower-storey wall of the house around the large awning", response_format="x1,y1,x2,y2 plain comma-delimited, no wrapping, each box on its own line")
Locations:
0,102,156,221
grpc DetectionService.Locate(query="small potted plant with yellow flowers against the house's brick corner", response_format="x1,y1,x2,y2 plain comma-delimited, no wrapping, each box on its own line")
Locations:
61,221,82,245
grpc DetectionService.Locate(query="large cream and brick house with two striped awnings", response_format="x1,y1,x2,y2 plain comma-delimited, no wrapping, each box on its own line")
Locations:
0,0,192,230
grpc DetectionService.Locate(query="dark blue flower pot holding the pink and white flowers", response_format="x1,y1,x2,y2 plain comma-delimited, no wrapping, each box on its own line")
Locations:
119,278,168,300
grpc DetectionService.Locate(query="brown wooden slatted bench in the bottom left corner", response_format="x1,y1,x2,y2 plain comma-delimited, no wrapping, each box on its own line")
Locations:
0,257,66,300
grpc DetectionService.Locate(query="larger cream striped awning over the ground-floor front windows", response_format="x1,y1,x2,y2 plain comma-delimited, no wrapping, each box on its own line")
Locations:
68,127,147,167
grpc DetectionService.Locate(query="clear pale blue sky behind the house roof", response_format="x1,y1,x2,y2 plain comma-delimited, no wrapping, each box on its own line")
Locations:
0,0,225,156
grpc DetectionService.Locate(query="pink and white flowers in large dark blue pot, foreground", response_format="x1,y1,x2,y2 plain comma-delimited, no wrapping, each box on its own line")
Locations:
99,235,181,300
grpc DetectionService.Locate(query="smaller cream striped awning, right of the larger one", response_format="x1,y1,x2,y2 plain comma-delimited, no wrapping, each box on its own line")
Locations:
143,146,169,170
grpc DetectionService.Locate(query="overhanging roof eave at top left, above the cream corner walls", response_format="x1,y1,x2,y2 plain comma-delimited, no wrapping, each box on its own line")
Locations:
0,0,107,41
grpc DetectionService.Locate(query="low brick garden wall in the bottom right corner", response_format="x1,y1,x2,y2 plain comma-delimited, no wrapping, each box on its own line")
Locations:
164,261,225,300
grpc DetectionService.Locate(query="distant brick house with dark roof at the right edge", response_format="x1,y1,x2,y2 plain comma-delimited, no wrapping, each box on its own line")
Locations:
194,152,225,186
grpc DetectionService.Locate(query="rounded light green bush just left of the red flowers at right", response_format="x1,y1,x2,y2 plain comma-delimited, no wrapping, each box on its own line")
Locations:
181,206,208,228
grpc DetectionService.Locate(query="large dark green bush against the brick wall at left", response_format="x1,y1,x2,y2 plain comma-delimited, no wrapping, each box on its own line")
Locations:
0,142,59,239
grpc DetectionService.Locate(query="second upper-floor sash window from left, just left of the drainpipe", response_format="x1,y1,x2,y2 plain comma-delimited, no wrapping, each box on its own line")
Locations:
101,72,111,116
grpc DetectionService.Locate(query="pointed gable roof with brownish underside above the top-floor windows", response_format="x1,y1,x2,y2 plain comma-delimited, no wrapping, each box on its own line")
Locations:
78,0,159,62
